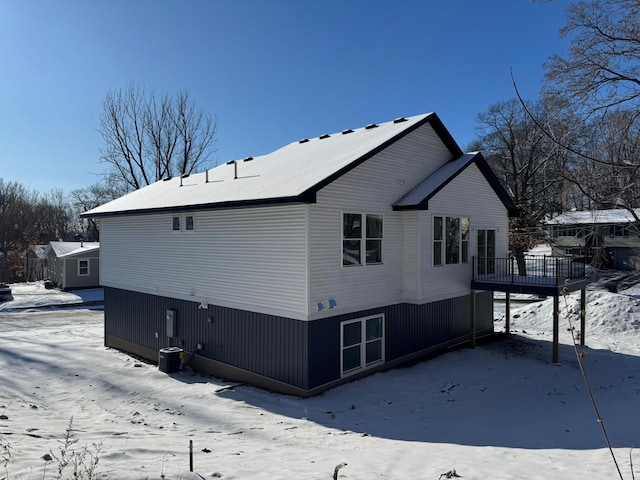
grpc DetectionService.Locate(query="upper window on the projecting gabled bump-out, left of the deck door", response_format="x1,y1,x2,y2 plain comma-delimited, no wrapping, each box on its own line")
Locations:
433,216,469,265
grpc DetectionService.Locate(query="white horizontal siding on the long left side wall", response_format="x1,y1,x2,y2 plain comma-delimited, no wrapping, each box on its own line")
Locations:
100,205,308,319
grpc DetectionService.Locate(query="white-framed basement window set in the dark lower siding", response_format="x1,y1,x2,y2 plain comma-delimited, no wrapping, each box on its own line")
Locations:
340,315,384,375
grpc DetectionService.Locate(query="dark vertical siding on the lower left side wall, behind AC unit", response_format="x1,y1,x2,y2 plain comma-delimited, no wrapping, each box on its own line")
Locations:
104,288,308,389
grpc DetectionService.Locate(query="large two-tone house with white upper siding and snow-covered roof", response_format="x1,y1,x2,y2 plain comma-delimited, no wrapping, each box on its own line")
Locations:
83,113,516,396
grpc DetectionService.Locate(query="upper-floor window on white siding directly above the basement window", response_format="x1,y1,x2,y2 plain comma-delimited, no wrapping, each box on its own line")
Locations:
342,213,382,266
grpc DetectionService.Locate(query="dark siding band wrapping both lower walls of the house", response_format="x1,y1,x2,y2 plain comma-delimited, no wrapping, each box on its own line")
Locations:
105,288,493,391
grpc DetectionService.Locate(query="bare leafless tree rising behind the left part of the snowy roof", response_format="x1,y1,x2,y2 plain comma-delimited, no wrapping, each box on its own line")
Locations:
100,83,217,190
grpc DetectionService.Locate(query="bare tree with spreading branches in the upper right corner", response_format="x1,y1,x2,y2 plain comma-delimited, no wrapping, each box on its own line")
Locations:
514,0,640,222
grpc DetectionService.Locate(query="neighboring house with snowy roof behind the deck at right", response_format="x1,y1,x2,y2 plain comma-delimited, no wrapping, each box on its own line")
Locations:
546,209,640,270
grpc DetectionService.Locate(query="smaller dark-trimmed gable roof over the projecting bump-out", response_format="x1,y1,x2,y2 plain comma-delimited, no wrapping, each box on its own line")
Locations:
393,152,518,217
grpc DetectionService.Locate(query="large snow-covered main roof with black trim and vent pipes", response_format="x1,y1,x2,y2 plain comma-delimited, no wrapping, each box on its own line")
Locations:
82,113,462,217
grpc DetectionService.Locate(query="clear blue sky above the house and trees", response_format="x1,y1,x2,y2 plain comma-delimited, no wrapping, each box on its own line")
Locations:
0,0,569,193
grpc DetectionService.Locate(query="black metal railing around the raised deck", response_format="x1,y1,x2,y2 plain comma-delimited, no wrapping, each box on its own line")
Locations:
473,255,586,285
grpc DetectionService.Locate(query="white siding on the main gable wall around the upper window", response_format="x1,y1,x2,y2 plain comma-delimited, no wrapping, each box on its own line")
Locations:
309,121,451,318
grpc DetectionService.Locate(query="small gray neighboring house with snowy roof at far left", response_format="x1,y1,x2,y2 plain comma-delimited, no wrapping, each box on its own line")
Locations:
46,242,100,290
